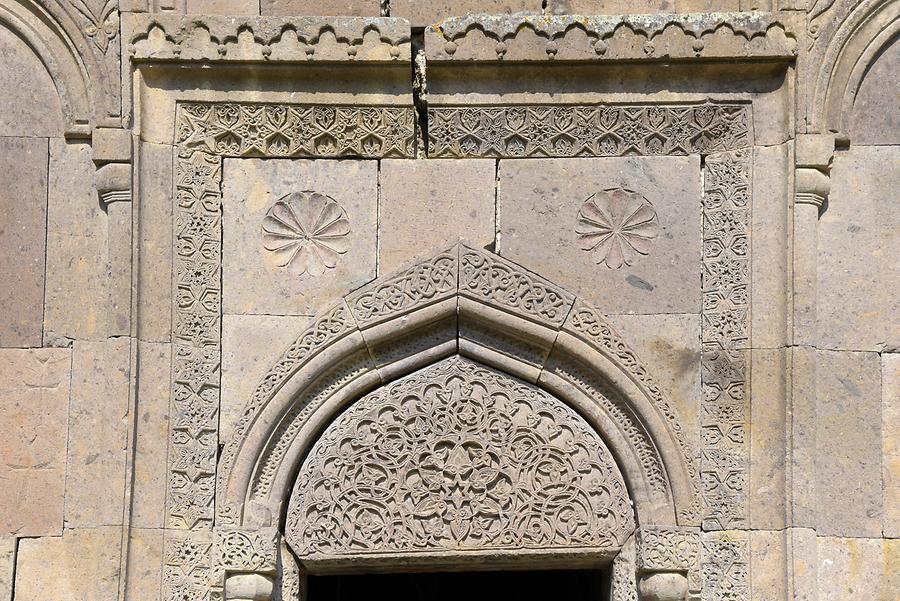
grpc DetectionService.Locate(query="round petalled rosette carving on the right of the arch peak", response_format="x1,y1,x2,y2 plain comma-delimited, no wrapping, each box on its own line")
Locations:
575,188,659,269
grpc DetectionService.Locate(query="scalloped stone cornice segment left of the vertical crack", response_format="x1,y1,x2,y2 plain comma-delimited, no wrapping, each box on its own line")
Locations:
123,13,410,63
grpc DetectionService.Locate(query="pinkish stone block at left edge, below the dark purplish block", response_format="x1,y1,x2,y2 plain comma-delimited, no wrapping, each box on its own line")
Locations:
0,349,71,536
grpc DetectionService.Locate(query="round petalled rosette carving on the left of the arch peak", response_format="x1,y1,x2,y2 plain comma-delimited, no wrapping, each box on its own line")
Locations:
262,191,350,276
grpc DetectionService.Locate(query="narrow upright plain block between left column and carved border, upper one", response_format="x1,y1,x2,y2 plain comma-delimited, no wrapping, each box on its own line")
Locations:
134,142,173,342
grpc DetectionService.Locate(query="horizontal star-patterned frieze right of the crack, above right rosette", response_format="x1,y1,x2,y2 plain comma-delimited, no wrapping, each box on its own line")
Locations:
428,103,751,158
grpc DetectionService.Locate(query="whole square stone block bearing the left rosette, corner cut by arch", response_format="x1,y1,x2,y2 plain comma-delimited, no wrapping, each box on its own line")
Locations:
222,159,378,315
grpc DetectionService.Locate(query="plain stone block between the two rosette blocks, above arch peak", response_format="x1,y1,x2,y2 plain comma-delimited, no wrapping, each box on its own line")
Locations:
378,159,496,273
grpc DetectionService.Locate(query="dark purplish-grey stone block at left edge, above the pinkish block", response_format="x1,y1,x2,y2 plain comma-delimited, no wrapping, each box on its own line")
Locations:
0,137,49,347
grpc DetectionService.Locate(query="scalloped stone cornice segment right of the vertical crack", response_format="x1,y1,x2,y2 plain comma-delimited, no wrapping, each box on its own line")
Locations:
425,12,797,62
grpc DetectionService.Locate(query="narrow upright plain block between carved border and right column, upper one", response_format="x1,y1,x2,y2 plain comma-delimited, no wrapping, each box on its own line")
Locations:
750,144,792,348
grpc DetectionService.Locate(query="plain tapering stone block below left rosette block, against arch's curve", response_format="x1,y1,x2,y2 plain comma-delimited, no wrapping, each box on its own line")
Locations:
219,315,310,441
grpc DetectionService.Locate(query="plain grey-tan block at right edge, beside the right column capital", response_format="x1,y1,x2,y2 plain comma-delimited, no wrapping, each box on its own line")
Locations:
818,146,900,351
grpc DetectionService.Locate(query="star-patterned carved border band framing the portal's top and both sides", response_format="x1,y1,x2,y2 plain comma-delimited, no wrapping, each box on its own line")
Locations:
163,102,752,599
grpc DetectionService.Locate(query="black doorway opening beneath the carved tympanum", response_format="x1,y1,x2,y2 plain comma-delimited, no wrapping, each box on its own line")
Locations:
308,570,608,601
